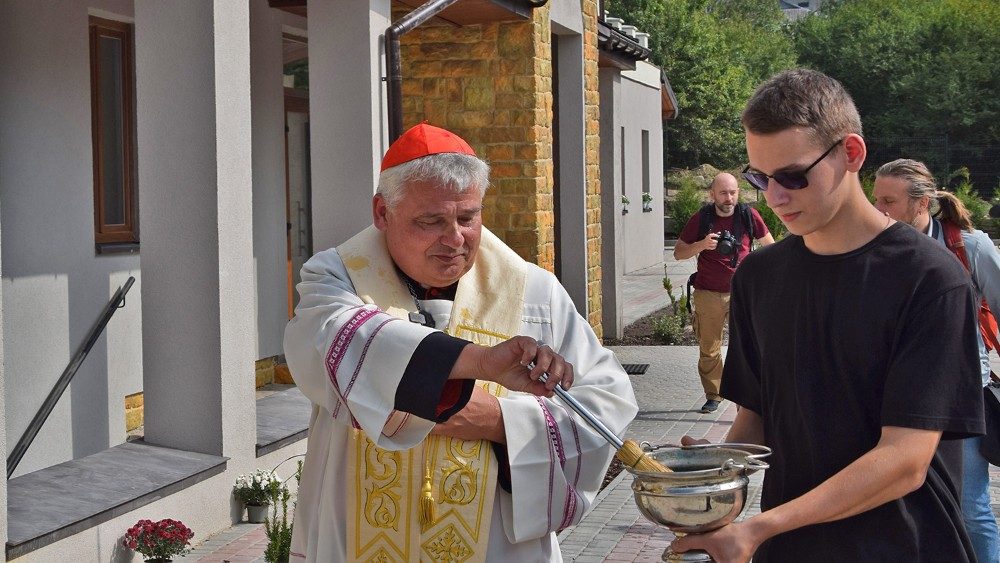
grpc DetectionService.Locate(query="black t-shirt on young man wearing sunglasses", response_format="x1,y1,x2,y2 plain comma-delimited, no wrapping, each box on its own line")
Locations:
722,224,983,563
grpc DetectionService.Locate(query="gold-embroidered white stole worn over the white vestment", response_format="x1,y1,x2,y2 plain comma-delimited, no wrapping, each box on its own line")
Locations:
337,226,527,563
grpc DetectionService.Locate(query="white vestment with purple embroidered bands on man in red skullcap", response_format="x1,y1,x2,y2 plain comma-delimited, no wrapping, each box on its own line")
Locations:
284,229,637,563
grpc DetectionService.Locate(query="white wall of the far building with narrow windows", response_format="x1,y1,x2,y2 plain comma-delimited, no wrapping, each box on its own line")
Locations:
617,61,663,274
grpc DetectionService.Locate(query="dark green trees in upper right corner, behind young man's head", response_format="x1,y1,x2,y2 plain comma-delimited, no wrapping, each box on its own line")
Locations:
792,0,1000,188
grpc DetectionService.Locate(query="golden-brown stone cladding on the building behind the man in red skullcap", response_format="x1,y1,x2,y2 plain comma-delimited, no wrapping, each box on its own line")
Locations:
393,0,601,334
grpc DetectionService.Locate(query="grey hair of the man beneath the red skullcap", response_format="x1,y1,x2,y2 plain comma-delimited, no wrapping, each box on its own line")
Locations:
375,152,490,208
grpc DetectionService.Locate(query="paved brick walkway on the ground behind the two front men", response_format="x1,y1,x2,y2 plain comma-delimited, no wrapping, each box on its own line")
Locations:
184,248,1000,563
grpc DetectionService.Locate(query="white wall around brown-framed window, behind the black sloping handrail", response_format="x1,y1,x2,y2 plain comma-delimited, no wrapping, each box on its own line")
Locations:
0,0,142,475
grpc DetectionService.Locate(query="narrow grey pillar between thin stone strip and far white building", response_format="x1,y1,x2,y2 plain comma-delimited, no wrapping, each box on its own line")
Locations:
599,68,625,338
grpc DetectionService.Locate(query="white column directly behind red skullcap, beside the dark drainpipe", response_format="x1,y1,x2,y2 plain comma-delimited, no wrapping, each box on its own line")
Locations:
308,0,392,251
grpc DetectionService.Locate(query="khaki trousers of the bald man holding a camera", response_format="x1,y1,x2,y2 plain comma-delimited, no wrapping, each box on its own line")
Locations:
691,289,729,401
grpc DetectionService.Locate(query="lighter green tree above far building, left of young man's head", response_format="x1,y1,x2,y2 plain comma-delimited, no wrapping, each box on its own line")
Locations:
607,0,795,168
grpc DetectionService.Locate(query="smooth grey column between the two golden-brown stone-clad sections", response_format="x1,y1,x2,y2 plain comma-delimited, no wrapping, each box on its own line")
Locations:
552,35,588,318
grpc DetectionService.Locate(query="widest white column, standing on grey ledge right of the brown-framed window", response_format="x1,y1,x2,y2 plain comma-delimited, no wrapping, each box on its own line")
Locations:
135,0,256,458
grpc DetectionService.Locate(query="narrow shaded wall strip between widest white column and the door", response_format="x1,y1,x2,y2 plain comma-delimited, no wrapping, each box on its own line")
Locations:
250,0,288,359
